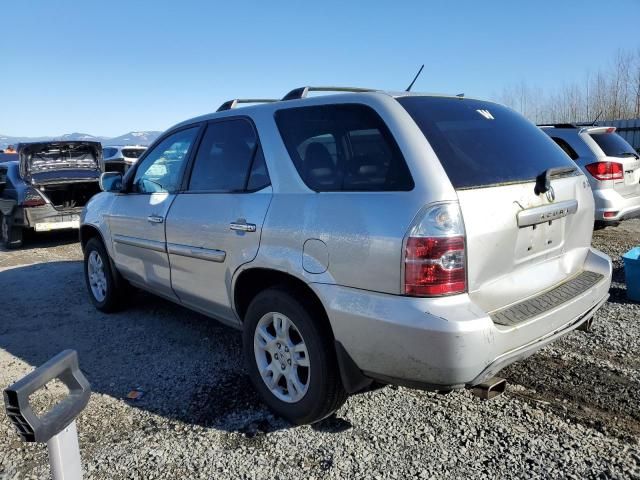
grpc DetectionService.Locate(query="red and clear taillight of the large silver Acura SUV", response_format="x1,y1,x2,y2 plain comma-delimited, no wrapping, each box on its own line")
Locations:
404,203,467,297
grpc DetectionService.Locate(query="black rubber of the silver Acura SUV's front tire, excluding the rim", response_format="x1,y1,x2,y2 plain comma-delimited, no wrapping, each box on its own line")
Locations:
84,238,124,313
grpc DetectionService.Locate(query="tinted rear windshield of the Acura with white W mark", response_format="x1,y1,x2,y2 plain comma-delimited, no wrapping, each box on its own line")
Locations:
398,97,575,189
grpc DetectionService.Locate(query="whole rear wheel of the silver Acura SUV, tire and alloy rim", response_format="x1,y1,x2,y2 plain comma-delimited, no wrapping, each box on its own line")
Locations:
243,287,347,425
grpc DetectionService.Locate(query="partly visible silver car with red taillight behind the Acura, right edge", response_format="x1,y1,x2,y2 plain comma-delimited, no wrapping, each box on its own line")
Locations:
541,123,640,225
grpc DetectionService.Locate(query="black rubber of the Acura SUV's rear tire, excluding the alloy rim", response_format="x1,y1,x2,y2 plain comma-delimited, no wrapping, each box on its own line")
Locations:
243,287,347,425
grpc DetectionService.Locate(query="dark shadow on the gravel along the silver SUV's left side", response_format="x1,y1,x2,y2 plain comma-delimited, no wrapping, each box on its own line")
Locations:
0,261,291,438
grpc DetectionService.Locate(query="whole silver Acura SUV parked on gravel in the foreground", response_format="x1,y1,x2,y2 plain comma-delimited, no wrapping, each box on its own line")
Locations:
80,87,611,423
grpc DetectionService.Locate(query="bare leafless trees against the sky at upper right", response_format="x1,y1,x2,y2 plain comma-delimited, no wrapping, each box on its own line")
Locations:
496,47,640,123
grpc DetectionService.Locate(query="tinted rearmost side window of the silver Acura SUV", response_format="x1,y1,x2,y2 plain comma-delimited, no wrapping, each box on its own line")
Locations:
276,104,414,192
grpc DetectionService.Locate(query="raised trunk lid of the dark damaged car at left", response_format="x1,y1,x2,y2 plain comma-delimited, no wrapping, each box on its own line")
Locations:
18,142,103,185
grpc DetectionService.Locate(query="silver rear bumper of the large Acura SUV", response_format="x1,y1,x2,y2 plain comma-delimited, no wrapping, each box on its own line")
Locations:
312,249,611,390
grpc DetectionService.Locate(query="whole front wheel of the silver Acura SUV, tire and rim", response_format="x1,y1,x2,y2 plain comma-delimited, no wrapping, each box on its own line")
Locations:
84,238,124,313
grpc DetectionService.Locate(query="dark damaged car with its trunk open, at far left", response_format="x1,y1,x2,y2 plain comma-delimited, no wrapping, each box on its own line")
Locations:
0,141,104,248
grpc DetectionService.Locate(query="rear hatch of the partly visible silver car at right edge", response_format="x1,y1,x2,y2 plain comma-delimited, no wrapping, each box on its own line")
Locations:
581,127,640,197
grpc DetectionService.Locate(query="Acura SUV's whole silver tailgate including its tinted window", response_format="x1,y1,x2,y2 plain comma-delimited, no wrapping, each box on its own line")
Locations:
398,96,594,312
